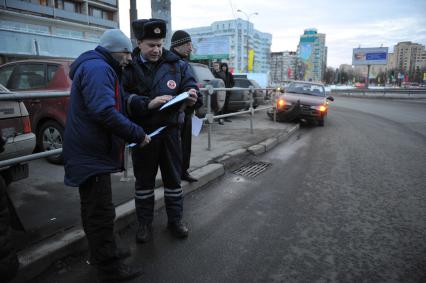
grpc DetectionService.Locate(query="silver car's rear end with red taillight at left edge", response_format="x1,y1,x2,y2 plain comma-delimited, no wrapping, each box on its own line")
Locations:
0,84,36,185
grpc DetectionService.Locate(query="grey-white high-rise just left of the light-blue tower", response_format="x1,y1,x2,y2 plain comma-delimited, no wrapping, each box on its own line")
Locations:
270,51,298,85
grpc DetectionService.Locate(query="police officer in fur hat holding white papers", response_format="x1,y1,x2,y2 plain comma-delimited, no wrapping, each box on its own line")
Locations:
124,19,201,243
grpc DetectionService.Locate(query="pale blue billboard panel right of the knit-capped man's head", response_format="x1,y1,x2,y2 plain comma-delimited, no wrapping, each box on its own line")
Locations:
191,36,229,60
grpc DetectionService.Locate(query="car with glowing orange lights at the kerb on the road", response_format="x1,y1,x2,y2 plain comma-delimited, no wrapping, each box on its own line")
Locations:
267,81,334,126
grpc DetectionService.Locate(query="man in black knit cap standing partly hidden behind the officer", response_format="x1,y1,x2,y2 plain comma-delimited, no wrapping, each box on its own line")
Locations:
170,30,202,182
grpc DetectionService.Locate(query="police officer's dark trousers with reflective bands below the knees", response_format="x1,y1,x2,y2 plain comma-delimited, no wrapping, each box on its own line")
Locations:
132,126,183,224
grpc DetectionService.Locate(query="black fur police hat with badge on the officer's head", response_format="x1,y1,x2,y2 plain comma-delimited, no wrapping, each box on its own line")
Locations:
132,19,167,40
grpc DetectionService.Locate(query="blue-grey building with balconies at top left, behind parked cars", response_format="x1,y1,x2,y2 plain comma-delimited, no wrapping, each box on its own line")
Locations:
0,0,119,63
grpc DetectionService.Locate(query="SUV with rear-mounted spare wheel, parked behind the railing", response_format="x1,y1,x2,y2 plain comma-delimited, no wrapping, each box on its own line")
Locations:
189,62,226,117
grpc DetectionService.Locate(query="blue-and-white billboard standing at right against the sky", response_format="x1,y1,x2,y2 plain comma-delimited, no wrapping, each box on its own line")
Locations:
352,47,388,65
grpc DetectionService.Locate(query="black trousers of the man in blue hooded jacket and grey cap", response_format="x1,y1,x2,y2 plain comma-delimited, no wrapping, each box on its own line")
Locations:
79,173,117,264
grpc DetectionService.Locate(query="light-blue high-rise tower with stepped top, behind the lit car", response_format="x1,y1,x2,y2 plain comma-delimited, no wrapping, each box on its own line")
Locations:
297,29,327,81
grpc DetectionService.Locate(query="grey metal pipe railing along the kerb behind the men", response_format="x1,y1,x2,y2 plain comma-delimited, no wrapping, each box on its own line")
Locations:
0,85,277,172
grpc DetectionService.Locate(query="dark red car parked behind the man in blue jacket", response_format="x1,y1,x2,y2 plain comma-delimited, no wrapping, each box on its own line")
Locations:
0,60,72,163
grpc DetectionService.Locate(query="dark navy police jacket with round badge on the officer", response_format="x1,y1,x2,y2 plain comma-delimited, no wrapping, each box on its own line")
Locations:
123,48,202,132
